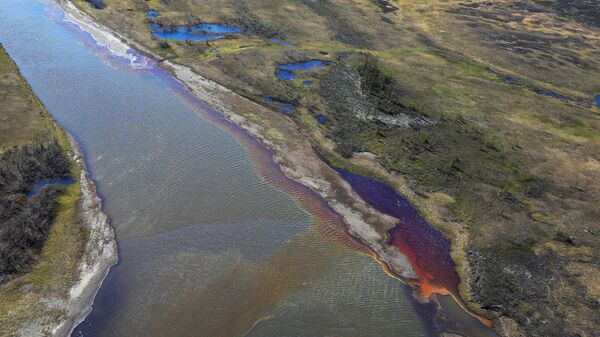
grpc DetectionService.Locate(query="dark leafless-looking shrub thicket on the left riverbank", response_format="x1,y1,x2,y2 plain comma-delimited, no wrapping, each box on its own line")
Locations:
0,140,70,283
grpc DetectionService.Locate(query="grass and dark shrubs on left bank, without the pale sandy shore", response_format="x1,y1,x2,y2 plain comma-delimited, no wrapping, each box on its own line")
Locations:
0,46,88,336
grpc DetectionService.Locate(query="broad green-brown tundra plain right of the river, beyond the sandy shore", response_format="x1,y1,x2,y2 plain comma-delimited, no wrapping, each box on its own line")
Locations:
73,0,600,336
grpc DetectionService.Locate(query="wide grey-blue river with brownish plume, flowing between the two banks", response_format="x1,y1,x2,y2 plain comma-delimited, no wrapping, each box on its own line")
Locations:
0,0,446,337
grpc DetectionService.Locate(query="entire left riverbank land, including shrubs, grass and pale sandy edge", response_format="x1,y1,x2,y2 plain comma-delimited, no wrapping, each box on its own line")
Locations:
0,46,116,336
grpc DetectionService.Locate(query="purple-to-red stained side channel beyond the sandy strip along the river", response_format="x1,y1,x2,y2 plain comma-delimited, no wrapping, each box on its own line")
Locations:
337,169,497,336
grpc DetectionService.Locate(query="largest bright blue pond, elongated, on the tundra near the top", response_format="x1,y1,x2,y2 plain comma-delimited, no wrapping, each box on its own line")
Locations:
150,23,244,41
